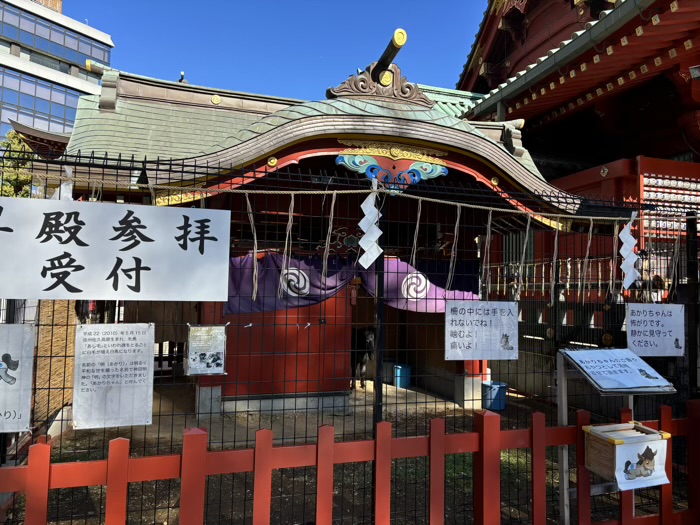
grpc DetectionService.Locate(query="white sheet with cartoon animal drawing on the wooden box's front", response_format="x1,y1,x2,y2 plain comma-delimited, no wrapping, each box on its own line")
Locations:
615,439,668,490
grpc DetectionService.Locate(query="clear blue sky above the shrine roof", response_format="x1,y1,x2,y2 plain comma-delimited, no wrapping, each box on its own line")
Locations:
63,0,487,100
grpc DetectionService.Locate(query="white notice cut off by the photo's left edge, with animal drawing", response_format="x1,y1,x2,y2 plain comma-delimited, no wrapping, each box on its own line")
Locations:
0,324,34,434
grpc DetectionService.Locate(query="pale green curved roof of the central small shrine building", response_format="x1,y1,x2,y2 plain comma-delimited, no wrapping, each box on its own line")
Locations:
66,75,542,179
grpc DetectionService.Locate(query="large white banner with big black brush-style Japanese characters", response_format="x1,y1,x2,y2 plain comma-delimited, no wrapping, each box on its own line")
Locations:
0,197,230,301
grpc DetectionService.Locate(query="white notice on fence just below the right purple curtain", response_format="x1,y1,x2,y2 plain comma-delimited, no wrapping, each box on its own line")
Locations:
445,301,518,361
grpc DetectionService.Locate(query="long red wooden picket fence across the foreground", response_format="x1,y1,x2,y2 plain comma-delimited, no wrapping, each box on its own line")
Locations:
0,401,700,525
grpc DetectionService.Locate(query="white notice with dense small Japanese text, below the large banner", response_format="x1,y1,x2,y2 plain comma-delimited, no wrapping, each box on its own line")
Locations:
73,323,155,429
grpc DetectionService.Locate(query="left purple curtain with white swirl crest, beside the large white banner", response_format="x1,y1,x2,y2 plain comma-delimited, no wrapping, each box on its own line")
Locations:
224,253,354,314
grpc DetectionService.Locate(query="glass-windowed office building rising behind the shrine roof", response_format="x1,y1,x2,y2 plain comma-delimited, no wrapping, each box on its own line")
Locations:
0,0,113,136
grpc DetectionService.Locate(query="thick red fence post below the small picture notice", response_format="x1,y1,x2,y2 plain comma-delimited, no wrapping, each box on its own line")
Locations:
180,428,208,525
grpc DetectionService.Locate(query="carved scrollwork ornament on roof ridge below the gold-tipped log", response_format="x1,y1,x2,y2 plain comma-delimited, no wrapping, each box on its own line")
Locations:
326,62,435,108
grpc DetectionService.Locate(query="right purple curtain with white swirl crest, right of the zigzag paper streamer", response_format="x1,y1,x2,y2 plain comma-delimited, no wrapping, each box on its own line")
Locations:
361,257,479,313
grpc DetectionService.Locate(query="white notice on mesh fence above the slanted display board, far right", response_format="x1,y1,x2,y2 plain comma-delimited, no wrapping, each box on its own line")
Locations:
627,303,685,357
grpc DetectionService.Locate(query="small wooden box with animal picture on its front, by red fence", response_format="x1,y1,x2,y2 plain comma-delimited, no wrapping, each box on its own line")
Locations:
583,421,671,482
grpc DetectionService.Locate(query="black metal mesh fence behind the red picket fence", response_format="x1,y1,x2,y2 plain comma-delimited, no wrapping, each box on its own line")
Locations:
0,149,697,524
